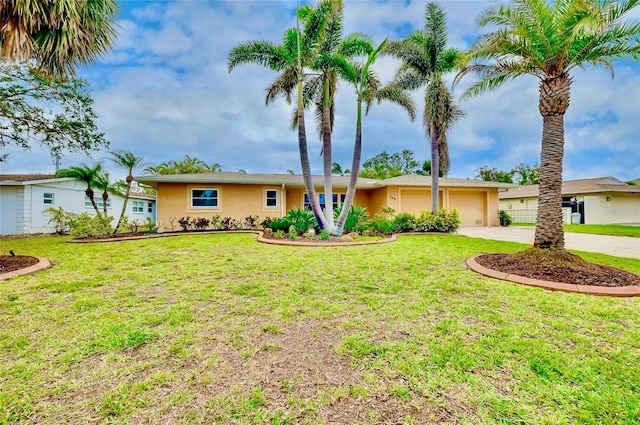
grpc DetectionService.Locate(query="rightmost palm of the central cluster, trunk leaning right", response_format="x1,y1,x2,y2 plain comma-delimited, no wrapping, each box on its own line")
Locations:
332,40,416,236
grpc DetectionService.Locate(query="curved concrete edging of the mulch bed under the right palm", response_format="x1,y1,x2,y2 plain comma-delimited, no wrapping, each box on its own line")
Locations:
467,256,640,297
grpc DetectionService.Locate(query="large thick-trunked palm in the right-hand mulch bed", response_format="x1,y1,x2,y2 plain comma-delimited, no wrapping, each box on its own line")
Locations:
461,0,640,252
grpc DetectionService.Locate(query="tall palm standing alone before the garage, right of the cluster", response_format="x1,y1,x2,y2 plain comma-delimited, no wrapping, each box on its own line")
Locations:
386,3,464,214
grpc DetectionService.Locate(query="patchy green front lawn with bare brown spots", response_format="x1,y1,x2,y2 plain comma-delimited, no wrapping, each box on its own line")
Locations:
0,234,640,425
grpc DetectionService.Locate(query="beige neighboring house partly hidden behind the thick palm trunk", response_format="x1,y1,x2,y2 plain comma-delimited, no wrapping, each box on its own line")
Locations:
500,177,640,224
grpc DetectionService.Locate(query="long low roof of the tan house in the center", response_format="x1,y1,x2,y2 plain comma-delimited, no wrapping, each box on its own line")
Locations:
135,172,516,189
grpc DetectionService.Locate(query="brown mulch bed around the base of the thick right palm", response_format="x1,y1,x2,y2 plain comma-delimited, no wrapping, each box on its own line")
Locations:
476,251,640,287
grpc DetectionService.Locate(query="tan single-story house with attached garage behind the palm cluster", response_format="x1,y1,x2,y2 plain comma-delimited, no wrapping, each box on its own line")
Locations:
135,172,515,230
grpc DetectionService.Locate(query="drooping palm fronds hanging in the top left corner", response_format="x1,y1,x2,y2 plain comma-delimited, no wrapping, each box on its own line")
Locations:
0,0,119,78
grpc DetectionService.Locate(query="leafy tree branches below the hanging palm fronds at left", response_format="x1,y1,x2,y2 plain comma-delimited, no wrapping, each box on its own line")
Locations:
0,64,109,162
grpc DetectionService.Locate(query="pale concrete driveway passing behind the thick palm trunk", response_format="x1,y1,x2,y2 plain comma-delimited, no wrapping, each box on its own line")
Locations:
458,226,640,259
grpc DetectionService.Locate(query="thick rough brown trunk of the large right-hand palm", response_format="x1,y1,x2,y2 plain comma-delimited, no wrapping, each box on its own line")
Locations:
533,74,571,251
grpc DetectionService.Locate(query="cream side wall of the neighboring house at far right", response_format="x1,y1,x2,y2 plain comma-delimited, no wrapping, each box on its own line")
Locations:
583,193,640,224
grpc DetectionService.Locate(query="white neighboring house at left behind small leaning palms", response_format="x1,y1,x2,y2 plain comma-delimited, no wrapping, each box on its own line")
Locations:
0,174,156,235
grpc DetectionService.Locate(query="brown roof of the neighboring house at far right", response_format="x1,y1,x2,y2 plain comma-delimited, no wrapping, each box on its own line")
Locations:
499,177,640,199
